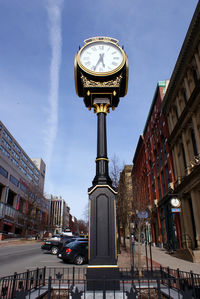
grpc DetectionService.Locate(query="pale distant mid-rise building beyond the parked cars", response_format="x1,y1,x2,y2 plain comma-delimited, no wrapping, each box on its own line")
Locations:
46,195,70,233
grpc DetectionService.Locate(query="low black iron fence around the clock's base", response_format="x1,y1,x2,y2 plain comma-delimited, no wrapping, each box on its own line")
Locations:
0,267,200,299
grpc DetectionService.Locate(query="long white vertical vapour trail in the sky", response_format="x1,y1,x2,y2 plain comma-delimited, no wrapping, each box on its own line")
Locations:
45,0,63,164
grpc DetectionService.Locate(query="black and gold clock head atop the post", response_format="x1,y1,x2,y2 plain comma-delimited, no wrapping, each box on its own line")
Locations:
74,37,128,109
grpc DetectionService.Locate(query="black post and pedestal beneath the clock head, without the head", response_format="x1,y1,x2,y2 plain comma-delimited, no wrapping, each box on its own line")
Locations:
87,98,119,289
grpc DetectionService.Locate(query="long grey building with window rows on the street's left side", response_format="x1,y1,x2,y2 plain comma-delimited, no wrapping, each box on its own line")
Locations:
0,122,49,240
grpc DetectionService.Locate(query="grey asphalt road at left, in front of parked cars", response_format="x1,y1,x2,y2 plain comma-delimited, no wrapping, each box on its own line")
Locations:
0,242,84,277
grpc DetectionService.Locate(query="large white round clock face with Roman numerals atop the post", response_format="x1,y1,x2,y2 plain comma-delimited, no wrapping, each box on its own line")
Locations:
78,41,125,76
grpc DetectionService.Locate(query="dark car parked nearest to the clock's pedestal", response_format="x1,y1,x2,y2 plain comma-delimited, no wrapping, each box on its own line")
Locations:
61,241,88,265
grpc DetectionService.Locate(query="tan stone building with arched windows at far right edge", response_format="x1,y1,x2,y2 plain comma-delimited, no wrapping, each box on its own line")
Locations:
163,2,200,261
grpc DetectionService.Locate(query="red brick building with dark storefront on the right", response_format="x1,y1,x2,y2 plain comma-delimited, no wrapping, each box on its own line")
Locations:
133,81,181,249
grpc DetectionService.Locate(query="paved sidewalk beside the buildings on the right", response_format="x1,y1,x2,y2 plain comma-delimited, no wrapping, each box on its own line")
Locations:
118,244,200,274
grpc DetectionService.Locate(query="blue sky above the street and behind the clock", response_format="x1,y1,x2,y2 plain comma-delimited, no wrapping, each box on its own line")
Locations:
0,0,197,218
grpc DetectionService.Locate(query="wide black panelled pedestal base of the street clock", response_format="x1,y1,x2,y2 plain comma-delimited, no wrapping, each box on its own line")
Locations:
87,185,119,290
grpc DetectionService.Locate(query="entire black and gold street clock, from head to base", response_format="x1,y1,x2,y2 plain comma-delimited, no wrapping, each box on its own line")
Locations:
74,37,128,290
